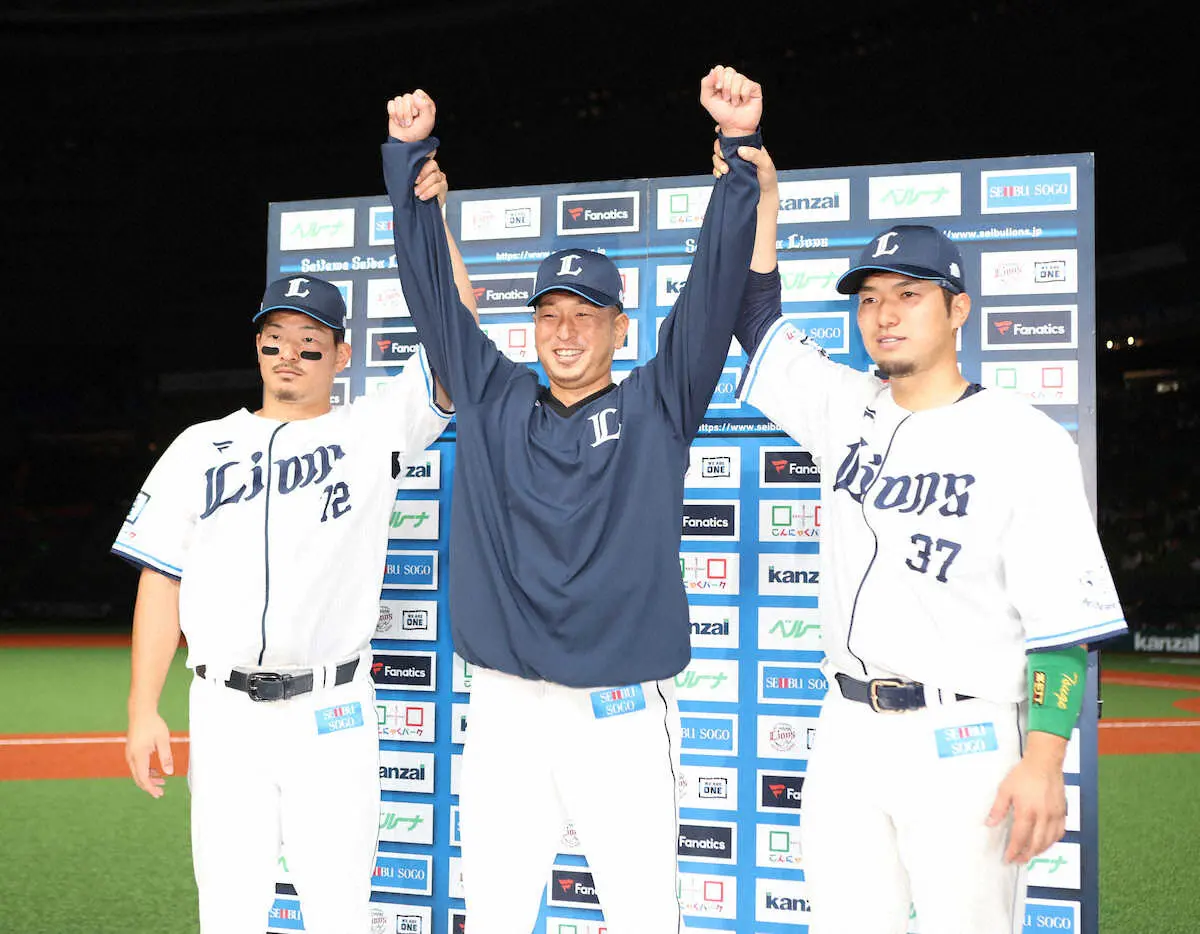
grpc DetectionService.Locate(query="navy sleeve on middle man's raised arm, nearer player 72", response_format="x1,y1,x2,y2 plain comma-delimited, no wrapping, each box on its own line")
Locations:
382,137,518,411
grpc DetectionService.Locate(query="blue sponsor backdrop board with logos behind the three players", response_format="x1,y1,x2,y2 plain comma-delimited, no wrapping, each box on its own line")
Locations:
266,154,1097,934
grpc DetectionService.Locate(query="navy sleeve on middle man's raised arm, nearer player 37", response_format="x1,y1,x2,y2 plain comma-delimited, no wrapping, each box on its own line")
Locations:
643,133,762,443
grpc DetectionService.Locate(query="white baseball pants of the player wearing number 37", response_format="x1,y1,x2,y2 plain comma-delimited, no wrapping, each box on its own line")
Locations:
800,681,1026,934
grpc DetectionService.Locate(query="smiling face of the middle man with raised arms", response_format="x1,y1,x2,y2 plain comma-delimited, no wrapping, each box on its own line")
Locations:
533,292,629,406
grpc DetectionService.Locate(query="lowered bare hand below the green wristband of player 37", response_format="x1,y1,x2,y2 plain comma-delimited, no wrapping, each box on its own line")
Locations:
988,734,1067,863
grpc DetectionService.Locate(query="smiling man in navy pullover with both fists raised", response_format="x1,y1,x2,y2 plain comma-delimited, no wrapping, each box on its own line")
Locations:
383,67,762,934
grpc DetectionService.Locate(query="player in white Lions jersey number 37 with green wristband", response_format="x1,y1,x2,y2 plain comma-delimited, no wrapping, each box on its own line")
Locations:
714,139,1126,934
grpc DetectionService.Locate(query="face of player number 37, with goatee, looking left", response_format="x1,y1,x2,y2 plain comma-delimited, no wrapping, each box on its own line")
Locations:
858,273,971,379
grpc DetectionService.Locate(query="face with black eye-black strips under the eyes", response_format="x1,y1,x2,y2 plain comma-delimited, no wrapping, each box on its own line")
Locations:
254,311,350,418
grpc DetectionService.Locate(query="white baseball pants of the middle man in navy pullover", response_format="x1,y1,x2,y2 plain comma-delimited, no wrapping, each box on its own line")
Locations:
460,667,682,934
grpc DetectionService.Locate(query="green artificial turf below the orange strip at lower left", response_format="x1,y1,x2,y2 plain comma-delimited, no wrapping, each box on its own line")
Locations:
0,778,196,934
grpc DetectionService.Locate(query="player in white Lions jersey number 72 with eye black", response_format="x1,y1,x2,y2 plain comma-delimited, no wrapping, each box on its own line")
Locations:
112,193,470,934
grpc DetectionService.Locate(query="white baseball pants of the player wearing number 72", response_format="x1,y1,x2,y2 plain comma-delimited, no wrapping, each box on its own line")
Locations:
187,657,380,934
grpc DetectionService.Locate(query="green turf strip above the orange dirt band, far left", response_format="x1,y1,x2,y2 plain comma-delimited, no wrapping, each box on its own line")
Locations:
0,647,190,729
